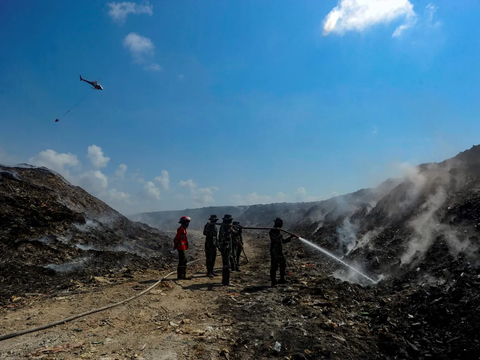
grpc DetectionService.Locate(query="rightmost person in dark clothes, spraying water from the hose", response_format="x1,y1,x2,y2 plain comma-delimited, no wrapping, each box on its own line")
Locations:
268,217,298,286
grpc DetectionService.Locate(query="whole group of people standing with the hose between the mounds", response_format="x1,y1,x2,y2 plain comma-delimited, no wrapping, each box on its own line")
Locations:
174,214,298,286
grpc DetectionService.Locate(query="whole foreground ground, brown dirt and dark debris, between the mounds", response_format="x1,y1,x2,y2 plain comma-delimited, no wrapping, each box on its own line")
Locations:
0,234,480,360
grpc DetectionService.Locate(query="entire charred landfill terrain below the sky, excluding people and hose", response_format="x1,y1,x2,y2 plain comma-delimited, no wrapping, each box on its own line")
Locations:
0,146,480,359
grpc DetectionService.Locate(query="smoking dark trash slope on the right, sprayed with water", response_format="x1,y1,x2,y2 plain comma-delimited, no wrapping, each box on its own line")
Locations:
132,146,480,359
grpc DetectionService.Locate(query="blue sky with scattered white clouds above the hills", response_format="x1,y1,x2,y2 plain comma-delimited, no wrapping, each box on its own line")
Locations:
0,0,480,214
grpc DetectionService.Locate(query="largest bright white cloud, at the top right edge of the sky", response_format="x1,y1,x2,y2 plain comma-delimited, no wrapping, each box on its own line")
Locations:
323,0,416,37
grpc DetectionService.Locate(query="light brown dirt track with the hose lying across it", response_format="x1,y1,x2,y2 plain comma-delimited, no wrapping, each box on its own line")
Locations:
0,233,310,360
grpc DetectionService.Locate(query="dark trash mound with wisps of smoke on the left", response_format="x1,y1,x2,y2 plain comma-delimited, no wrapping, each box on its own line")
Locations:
0,164,173,304
